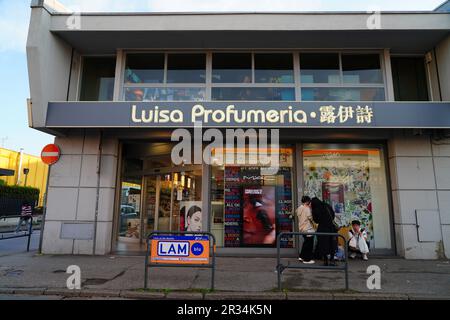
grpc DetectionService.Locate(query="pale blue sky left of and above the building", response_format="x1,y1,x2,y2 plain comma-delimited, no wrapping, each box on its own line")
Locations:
0,0,444,155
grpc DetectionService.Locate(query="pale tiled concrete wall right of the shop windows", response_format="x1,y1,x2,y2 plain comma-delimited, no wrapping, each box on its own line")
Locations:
389,130,450,259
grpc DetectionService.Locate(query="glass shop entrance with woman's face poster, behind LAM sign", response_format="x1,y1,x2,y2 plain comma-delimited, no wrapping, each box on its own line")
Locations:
141,166,202,241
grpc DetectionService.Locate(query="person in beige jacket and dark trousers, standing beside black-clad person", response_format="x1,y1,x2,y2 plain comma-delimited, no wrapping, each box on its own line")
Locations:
297,196,315,264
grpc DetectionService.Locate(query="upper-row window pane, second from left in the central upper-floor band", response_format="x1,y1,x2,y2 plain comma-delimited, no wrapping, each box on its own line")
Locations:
167,53,206,83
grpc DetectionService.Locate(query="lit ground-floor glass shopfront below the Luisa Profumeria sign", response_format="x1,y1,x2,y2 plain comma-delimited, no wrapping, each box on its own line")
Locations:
117,138,393,254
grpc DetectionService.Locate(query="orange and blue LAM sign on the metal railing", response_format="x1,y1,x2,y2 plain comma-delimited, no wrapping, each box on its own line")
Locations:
150,236,210,265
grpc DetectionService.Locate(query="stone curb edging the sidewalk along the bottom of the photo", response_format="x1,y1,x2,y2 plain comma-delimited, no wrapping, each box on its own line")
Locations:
0,288,450,301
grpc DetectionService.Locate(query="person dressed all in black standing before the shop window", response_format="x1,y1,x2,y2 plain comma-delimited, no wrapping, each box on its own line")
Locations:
311,198,337,266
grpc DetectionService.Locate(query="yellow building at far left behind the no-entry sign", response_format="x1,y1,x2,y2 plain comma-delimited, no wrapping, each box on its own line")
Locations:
0,148,48,206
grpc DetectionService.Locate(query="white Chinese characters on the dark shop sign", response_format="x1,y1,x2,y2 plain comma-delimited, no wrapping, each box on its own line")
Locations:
319,105,374,124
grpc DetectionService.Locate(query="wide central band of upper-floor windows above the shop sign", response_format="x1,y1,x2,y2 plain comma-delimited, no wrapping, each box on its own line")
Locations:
122,52,385,101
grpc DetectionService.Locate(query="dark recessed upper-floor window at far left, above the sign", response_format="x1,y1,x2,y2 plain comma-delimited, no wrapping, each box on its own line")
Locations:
80,57,116,101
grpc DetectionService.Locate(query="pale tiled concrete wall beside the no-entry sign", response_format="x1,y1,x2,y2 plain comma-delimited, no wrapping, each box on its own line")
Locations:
43,133,118,255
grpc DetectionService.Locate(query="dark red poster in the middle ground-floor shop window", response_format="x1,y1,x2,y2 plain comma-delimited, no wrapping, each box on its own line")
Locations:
243,186,276,245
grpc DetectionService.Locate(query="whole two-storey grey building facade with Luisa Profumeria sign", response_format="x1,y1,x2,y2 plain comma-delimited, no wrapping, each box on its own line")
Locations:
27,1,450,259
